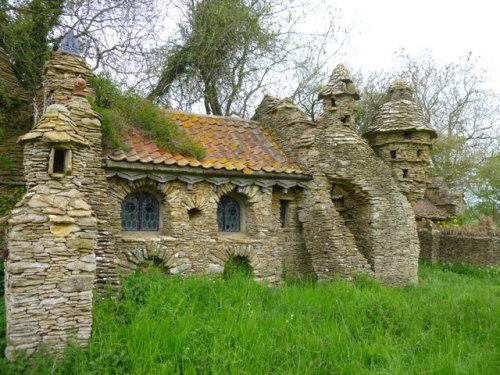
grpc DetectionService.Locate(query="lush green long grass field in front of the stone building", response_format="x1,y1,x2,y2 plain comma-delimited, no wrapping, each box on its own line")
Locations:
0,264,500,375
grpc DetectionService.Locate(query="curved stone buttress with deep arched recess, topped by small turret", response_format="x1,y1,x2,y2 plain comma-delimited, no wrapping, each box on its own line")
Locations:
256,65,419,285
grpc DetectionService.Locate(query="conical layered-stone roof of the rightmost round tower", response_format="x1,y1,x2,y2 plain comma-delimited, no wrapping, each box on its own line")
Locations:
364,79,437,138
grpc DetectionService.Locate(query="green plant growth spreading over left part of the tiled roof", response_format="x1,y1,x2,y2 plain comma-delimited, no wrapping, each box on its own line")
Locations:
90,77,204,158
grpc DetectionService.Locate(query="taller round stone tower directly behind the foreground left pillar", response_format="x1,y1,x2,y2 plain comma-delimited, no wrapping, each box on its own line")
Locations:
43,47,119,286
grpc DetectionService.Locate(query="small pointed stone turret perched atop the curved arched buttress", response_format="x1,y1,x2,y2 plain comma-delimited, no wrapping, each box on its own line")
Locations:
318,64,359,129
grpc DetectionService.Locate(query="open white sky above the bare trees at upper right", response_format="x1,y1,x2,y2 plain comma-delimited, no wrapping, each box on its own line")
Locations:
314,0,500,92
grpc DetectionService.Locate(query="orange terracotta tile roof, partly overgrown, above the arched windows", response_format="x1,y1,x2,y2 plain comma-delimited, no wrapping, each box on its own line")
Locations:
105,111,305,174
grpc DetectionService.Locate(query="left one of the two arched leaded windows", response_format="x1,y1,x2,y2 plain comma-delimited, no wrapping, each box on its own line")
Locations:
122,191,160,231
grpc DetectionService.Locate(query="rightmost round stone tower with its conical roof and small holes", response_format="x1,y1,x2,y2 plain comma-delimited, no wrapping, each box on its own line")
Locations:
364,79,437,204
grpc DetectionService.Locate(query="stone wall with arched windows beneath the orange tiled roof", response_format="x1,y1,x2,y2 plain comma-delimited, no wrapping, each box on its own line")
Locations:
109,178,308,284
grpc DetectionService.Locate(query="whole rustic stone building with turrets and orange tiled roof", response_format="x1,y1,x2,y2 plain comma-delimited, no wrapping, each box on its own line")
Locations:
4,45,435,355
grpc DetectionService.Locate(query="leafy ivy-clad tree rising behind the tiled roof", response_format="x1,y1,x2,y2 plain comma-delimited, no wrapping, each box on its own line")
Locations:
149,0,278,116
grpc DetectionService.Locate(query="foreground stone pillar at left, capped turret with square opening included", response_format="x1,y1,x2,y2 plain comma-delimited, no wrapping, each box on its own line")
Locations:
5,104,97,360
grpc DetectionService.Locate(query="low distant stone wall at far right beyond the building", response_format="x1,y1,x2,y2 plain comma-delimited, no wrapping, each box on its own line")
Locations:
418,228,500,267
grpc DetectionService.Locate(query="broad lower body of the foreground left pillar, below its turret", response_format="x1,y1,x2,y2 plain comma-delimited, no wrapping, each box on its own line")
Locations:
5,181,97,360
